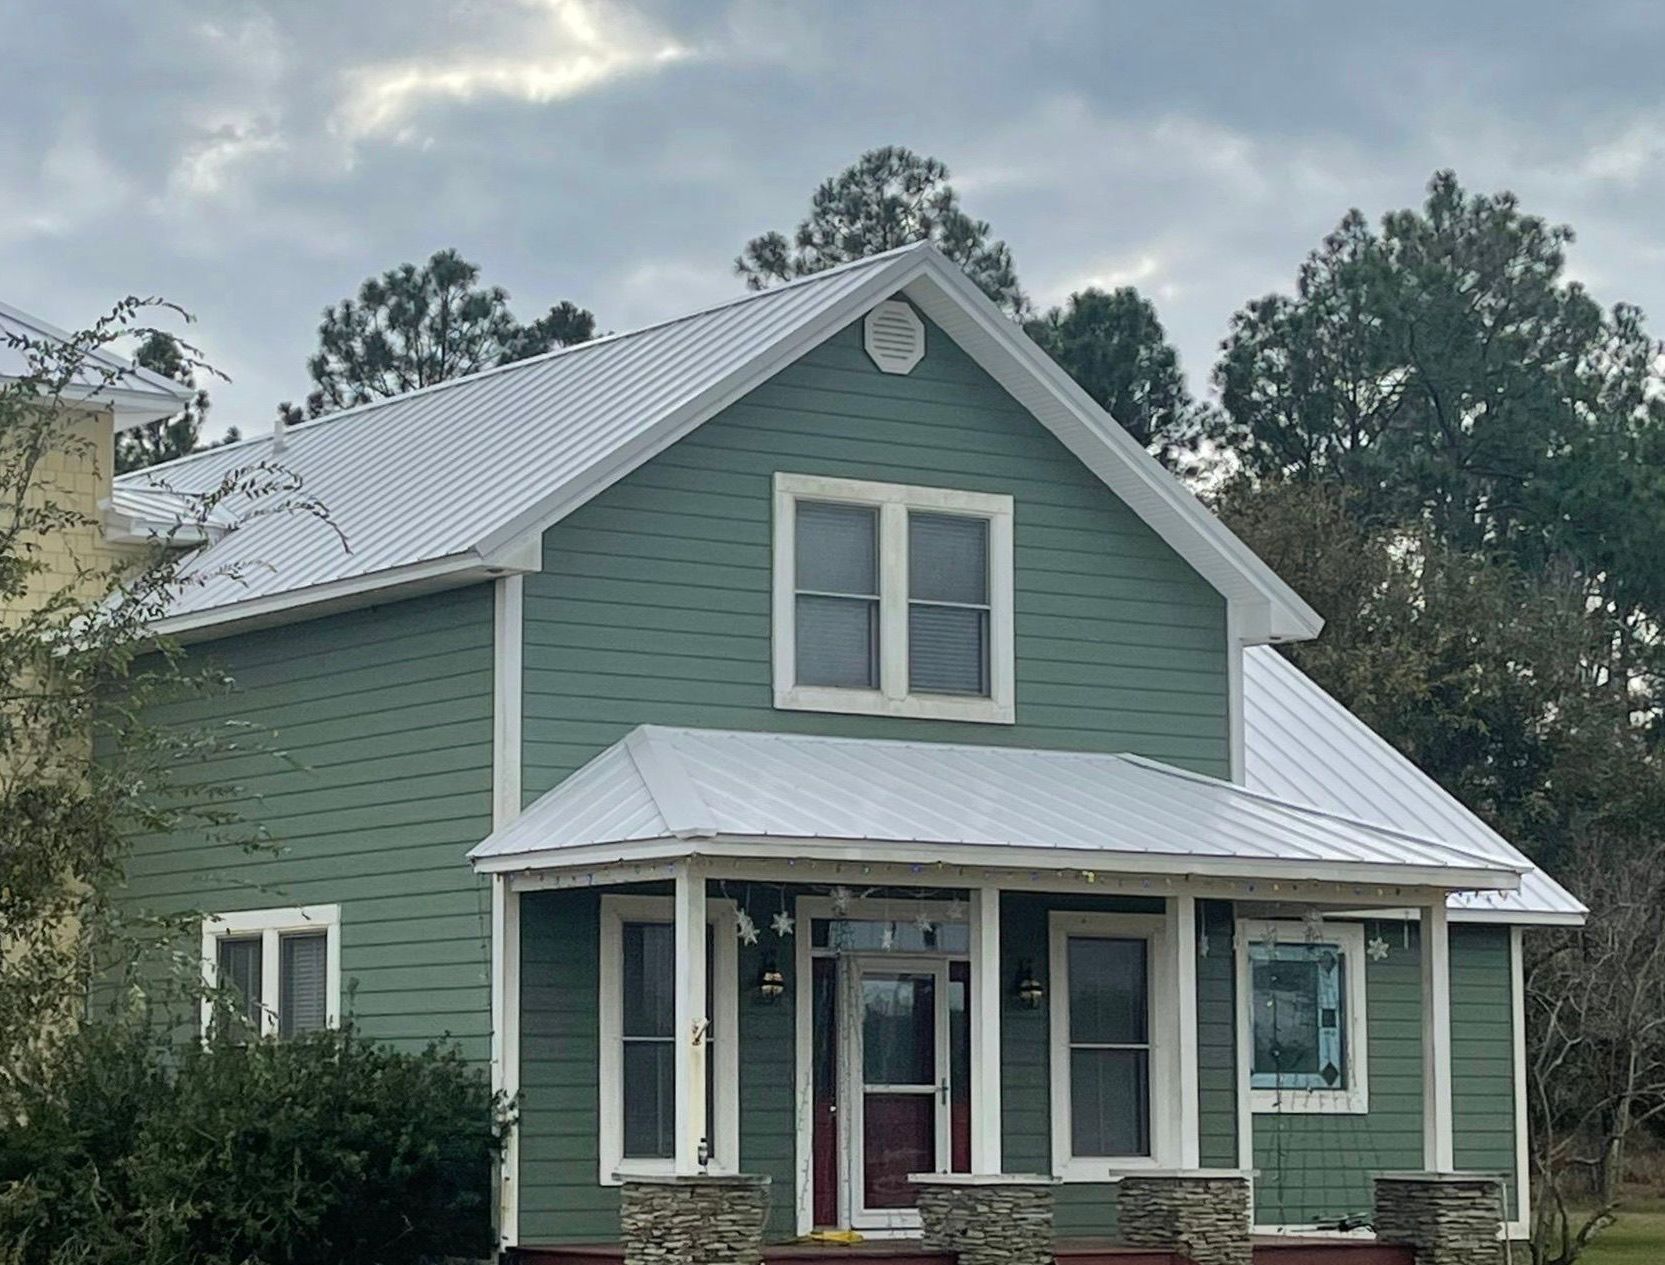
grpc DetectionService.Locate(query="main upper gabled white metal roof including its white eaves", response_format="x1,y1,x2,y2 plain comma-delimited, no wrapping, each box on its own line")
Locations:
110,245,1320,641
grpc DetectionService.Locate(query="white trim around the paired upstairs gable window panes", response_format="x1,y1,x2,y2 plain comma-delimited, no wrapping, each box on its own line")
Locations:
774,473,1017,724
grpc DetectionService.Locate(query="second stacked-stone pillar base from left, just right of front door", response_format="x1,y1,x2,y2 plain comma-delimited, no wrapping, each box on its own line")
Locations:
907,1173,1057,1265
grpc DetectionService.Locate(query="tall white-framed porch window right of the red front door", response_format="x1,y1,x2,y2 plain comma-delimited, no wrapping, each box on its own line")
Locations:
1049,912,1177,1182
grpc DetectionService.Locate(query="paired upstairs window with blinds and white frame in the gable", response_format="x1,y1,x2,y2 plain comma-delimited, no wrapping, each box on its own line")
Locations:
774,474,1014,724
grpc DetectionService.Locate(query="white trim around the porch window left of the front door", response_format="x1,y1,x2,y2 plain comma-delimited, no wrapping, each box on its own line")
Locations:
596,895,739,1185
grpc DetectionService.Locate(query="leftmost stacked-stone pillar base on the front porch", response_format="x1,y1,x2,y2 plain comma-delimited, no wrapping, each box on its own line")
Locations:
619,1173,769,1265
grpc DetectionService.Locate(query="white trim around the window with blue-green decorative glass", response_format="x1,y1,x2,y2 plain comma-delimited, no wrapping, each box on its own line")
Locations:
1235,919,1370,1115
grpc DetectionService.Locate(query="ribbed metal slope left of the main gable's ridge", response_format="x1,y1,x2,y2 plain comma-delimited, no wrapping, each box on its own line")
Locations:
114,253,907,616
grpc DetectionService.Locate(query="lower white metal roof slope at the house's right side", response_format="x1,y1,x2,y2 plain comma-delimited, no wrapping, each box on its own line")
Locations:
1244,646,1585,922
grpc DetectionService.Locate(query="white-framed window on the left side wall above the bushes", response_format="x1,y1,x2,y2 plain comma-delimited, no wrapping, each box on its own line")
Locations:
201,905,341,1037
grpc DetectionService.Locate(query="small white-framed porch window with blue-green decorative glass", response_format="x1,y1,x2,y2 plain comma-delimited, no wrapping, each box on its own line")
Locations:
1237,920,1369,1114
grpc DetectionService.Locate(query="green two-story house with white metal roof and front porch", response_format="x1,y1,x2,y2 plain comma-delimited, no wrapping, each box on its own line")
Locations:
122,248,1582,1250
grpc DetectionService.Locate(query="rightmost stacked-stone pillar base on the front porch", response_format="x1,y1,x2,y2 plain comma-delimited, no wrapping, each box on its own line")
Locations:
1375,1173,1503,1265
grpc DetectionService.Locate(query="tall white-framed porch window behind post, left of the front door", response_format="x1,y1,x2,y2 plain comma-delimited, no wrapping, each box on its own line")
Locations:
599,895,739,1185
